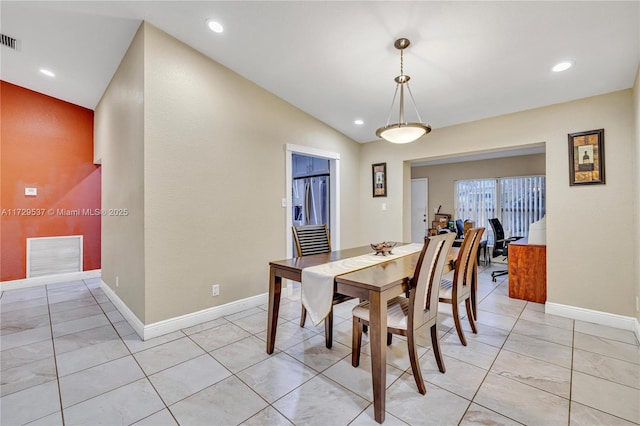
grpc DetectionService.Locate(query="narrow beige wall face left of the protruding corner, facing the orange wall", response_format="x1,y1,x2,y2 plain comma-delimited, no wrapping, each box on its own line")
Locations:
94,23,145,318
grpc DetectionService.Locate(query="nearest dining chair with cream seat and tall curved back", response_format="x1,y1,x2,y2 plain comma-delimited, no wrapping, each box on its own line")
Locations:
351,232,456,395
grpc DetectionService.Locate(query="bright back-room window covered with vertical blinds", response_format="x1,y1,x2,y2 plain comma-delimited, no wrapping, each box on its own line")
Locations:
454,176,546,240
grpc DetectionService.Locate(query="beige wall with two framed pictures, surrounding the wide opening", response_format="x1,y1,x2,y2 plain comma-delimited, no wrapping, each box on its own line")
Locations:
360,90,637,316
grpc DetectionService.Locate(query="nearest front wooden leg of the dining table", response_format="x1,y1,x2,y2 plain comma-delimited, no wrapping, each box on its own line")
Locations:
369,292,387,423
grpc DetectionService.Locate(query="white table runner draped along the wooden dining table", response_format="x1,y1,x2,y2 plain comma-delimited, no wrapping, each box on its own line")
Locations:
300,243,423,326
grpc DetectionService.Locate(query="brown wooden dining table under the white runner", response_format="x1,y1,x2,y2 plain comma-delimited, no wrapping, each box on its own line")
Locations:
267,246,457,423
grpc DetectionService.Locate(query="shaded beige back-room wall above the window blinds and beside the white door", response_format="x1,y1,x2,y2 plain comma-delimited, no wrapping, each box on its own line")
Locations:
411,154,545,221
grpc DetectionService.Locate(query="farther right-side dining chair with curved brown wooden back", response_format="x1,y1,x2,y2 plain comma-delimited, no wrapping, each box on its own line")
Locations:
439,228,484,346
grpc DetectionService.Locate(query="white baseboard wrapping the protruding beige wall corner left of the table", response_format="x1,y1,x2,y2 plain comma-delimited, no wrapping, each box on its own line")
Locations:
100,281,268,340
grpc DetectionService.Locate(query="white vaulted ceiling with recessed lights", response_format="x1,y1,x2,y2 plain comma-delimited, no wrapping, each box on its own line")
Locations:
0,0,640,142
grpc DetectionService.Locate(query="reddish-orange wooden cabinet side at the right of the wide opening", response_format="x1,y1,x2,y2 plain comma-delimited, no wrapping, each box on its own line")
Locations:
508,239,547,303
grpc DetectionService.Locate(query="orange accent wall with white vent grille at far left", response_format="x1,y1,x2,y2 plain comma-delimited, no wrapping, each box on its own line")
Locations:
0,81,101,281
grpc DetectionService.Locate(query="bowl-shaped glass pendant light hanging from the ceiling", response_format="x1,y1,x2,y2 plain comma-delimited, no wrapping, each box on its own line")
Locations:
376,38,431,143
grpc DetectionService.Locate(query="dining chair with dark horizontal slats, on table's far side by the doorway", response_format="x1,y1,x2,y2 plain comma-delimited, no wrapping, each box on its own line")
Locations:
292,224,353,348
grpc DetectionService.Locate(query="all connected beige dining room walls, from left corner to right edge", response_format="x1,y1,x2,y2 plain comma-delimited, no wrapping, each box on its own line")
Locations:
95,24,640,324
